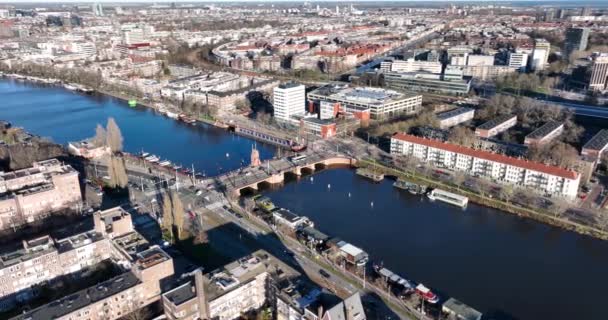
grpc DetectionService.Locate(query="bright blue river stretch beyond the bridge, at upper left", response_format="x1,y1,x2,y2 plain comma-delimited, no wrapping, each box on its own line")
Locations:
0,80,275,175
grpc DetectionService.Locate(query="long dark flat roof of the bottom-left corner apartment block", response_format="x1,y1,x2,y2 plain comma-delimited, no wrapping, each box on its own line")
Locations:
13,271,140,320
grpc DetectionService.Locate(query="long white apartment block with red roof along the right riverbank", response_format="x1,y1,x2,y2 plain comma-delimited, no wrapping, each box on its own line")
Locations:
391,133,581,200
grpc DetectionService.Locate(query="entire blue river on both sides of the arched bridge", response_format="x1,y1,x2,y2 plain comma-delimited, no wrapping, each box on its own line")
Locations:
0,80,608,320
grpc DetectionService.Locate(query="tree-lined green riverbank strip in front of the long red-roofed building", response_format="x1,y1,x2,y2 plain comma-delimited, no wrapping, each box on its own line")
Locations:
357,160,608,240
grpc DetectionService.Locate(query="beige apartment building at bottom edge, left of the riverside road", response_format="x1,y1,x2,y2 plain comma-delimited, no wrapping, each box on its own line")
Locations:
162,250,300,320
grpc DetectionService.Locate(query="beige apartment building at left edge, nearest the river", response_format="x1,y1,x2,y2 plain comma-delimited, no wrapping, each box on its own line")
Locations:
0,159,82,230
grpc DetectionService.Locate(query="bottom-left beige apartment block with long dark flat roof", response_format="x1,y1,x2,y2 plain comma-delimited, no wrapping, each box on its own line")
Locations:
12,247,174,320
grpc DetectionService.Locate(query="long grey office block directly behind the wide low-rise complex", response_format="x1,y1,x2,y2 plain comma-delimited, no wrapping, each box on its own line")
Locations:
384,72,471,95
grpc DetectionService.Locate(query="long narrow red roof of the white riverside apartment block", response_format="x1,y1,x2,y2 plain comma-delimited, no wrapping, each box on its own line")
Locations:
393,133,578,180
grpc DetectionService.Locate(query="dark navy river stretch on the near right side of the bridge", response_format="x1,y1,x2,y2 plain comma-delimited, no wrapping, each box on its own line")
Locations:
265,169,608,320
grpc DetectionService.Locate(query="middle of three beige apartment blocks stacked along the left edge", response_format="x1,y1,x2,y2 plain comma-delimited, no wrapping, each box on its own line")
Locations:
0,207,133,310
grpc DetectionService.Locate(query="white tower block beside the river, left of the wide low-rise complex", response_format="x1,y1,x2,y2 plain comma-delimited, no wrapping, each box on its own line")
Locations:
273,82,306,122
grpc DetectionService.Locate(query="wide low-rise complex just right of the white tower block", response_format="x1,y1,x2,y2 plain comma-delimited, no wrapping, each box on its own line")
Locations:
308,83,422,119
